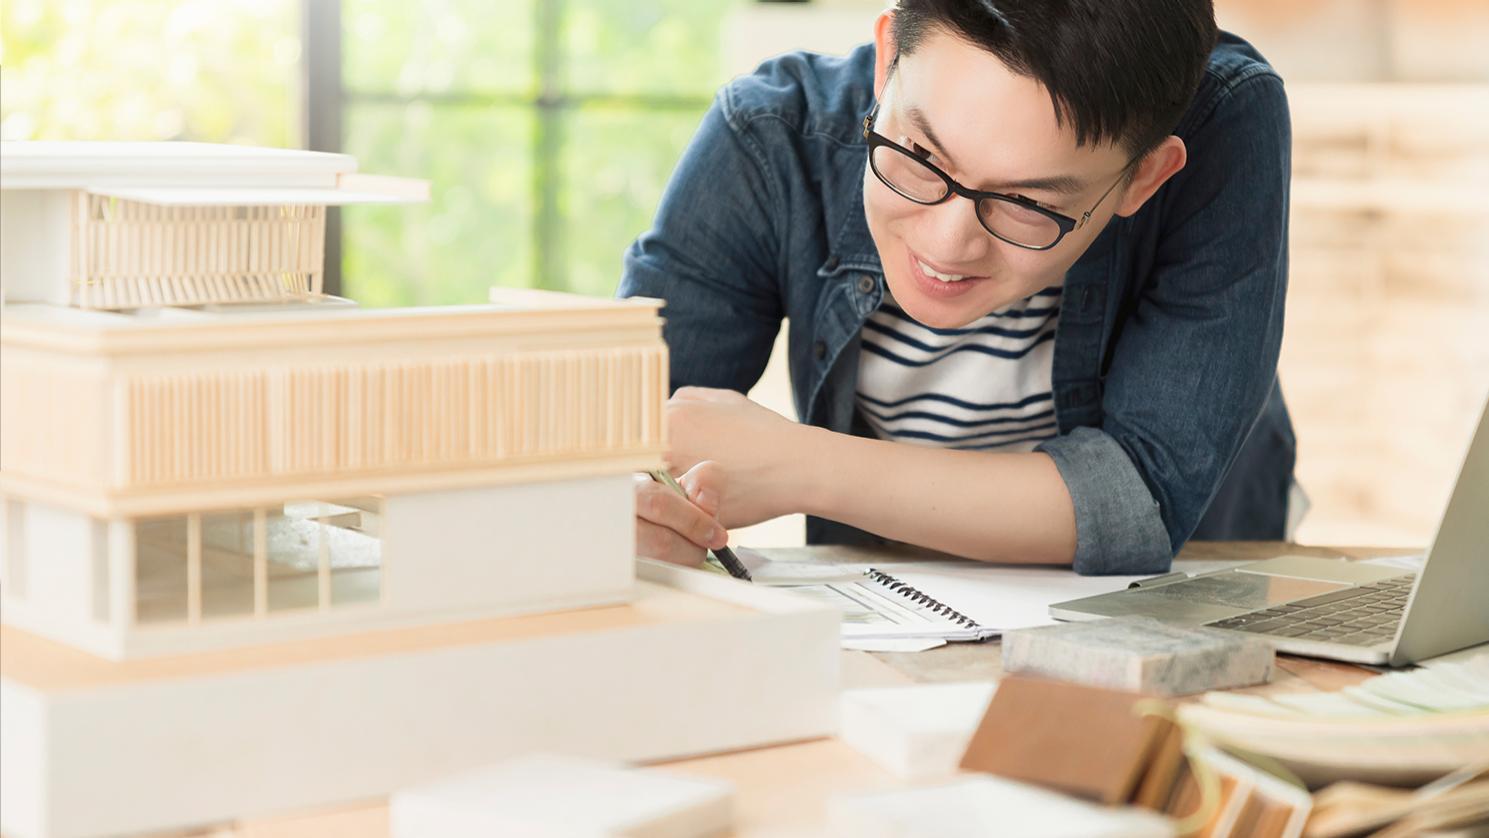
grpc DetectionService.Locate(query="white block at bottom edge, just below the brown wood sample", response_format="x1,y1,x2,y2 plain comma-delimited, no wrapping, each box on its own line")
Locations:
828,775,1173,838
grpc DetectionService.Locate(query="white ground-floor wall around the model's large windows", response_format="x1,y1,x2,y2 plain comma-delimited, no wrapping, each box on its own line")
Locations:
3,473,636,659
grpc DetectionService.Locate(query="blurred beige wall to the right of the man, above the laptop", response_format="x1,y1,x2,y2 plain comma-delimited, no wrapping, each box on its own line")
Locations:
1217,0,1489,546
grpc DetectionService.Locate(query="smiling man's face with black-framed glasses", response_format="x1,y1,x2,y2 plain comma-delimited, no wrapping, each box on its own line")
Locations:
864,27,1127,327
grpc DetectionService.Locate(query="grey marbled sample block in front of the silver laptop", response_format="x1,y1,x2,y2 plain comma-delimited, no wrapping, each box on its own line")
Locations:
1004,616,1275,695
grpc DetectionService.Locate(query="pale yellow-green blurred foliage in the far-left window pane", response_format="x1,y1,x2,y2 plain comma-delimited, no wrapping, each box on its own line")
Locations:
0,0,299,146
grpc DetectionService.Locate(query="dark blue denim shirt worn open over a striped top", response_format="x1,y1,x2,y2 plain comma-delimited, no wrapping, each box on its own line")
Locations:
619,34,1294,573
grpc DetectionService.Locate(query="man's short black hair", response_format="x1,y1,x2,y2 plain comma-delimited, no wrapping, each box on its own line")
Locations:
892,0,1217,156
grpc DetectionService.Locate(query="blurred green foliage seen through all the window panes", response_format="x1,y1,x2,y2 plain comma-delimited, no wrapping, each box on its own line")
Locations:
0,0,745,305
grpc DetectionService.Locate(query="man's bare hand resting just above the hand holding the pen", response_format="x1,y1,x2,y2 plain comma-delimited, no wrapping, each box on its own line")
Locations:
666,387,814,528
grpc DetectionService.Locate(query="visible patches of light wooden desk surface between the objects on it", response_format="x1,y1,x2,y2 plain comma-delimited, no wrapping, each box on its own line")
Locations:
226,542,1407,838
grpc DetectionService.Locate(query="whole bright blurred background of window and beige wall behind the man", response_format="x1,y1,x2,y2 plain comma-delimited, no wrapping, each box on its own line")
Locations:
0,0,1489,546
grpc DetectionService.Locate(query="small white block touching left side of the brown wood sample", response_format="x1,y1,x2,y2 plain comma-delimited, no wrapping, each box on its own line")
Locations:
838,682,995,780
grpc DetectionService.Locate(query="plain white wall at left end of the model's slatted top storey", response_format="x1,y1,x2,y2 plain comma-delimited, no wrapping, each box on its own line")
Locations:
0,189,71,305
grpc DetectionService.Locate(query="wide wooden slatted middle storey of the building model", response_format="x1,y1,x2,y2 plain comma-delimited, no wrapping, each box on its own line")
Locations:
0,305,667,514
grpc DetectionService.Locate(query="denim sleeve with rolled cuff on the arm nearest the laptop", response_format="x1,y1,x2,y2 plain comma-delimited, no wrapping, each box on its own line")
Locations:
1039,73,1291,573
